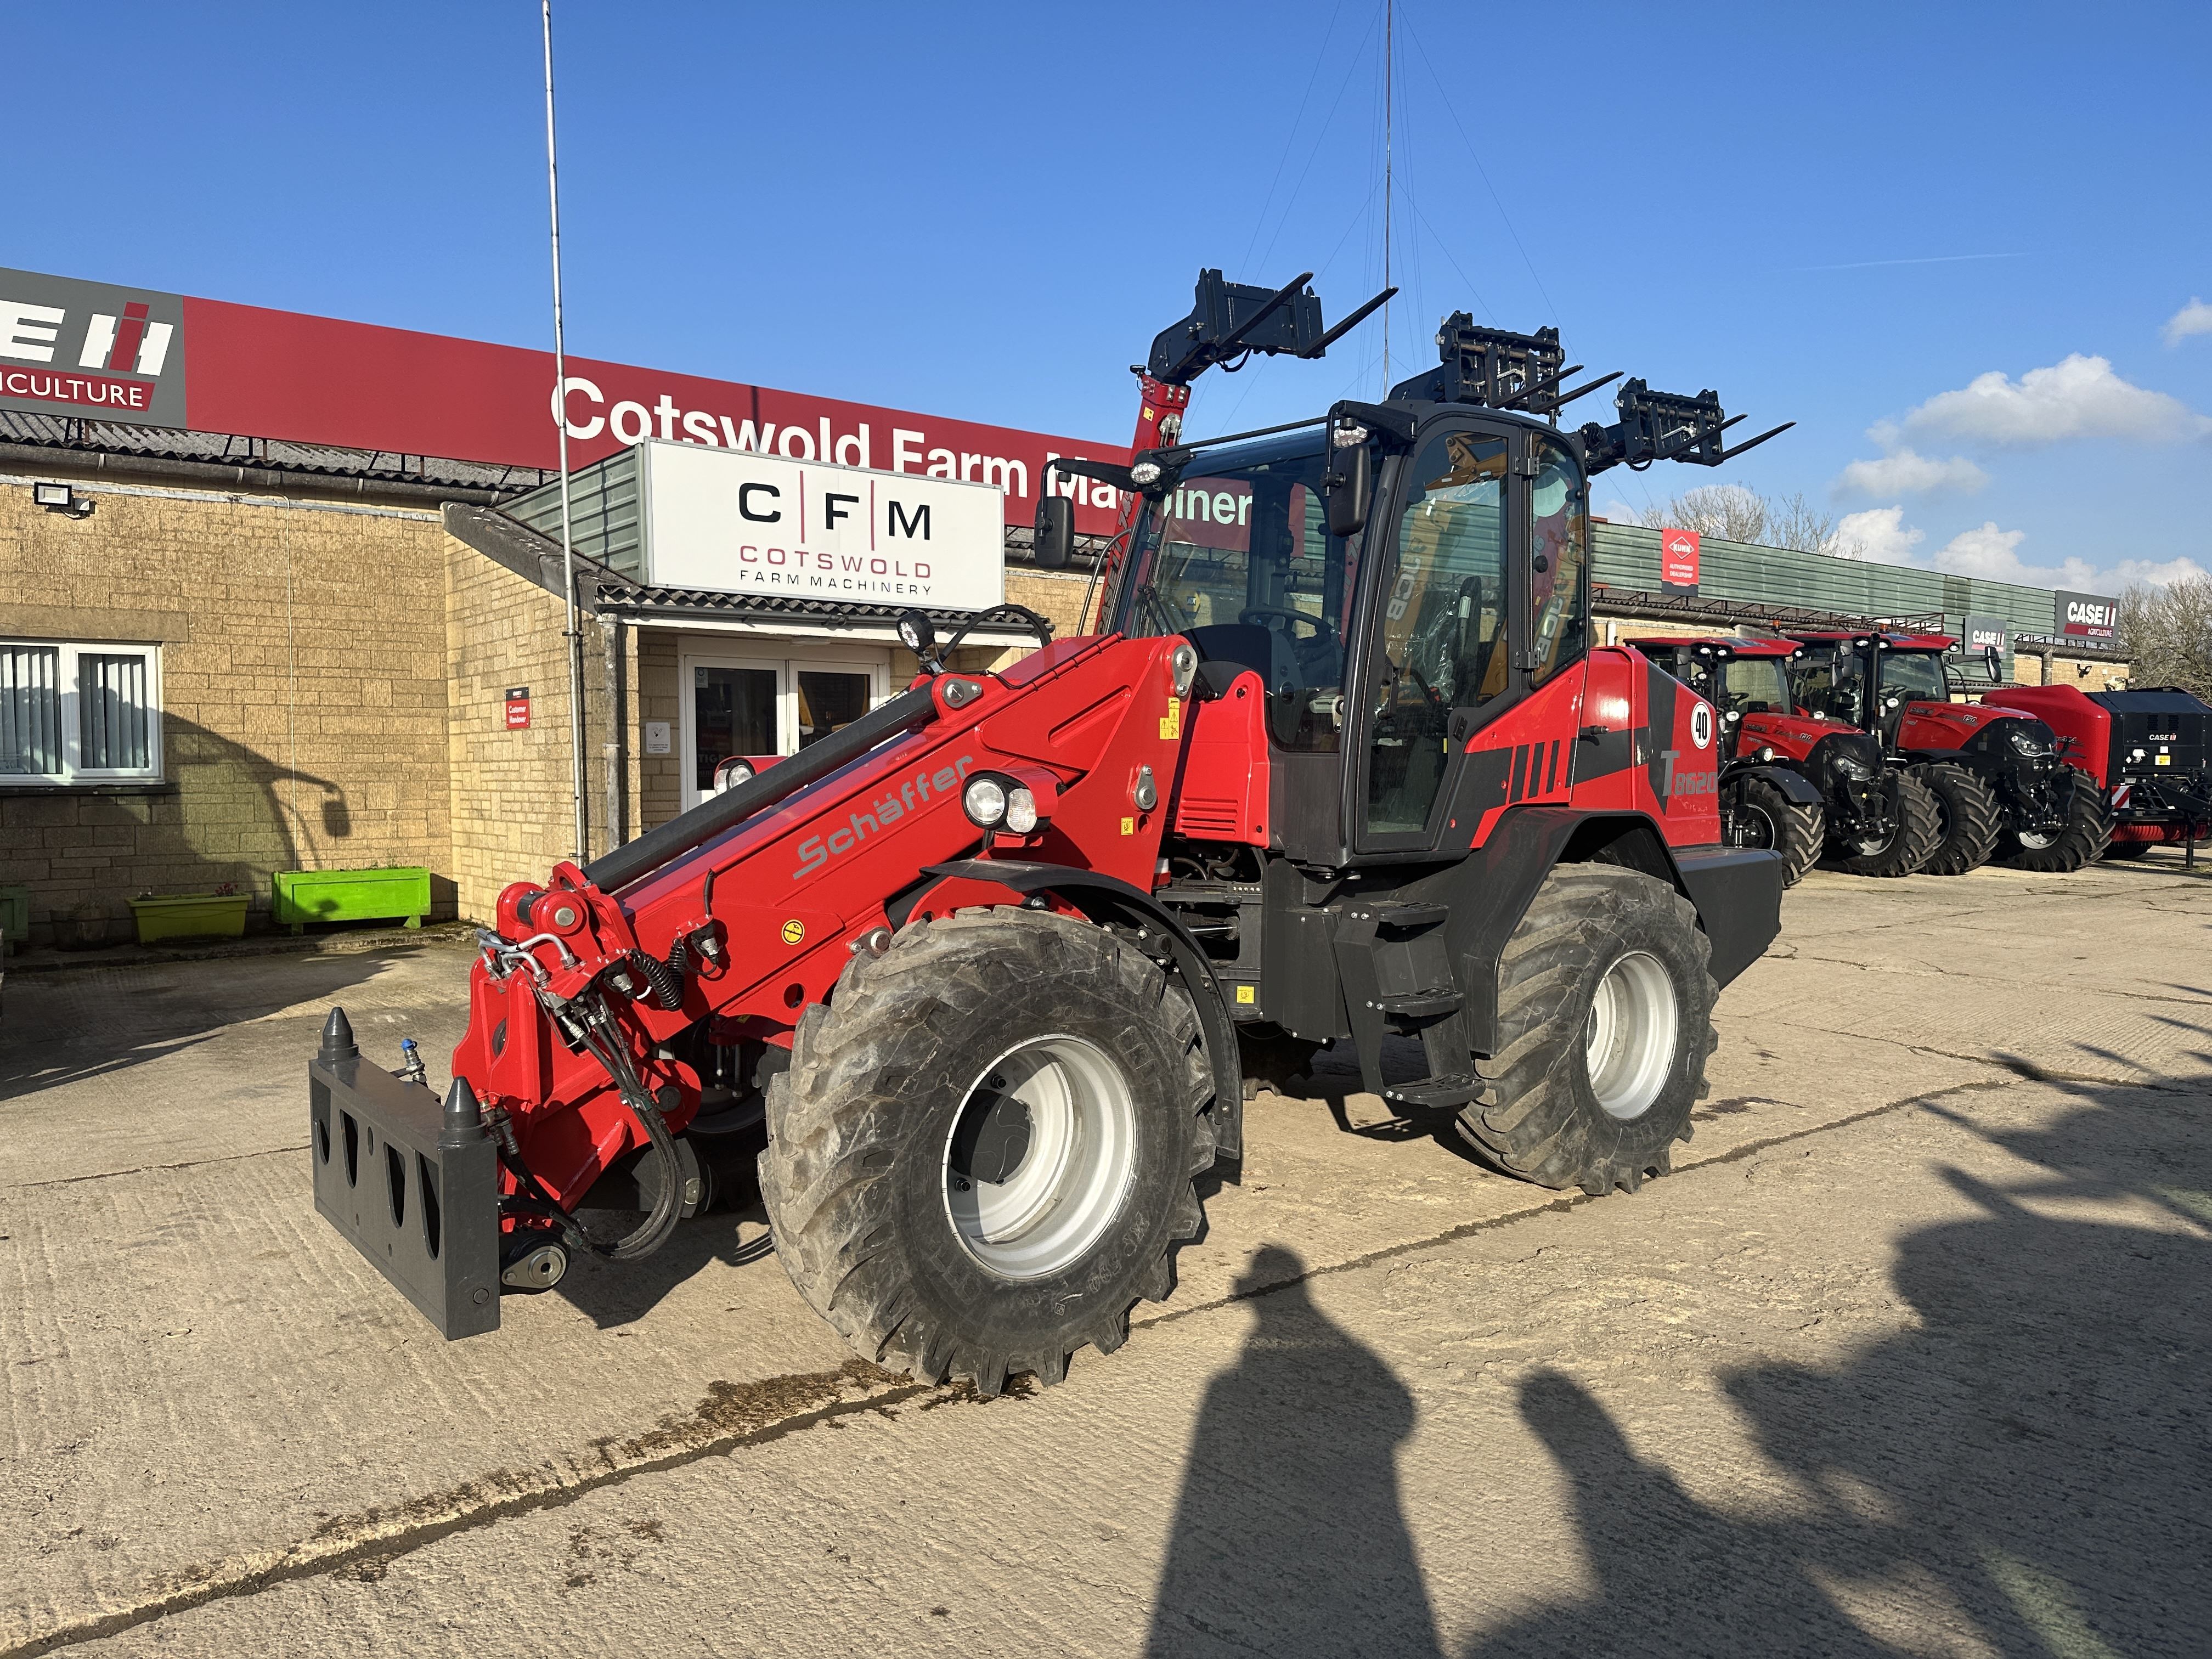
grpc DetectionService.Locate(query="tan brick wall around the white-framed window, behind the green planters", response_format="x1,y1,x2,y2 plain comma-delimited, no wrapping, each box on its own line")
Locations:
0,469,454,943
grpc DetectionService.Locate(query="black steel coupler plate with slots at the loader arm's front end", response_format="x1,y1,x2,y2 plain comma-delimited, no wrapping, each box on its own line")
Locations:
307,1009,500,1340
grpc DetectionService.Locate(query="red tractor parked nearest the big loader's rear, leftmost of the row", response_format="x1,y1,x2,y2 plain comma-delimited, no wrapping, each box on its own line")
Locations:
1628,635,1936,885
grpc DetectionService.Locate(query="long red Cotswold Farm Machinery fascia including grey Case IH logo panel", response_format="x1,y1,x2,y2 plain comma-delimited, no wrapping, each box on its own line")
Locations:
0,268,1128,535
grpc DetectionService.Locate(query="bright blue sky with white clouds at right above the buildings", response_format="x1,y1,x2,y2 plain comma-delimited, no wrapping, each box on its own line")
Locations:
0,0,2212,586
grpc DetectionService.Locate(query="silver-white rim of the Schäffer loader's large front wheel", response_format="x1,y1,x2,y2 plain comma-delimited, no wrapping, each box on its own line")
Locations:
943,1035,1137,1278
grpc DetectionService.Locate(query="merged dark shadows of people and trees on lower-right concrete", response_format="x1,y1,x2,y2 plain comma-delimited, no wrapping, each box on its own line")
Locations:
1148,1088,2212,1659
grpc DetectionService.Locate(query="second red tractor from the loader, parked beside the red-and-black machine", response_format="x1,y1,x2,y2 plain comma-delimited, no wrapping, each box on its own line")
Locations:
1790,633,2113,876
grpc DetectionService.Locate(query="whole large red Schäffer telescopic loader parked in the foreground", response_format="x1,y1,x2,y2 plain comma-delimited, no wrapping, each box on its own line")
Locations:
307,272,1781,1396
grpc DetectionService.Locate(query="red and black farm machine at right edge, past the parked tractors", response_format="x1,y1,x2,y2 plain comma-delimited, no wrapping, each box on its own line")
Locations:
1982,686,2212,860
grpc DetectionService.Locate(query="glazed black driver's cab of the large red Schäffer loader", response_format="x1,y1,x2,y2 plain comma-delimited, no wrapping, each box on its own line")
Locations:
1108,400,1590,865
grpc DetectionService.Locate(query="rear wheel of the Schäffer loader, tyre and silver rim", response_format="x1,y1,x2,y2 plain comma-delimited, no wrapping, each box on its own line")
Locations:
1460,865,1719,1197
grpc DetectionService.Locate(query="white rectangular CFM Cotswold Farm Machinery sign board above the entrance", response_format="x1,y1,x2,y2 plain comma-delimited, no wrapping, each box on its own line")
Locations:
637,440,1007,611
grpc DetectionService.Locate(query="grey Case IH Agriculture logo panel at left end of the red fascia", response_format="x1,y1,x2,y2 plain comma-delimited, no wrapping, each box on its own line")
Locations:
0,270,186,427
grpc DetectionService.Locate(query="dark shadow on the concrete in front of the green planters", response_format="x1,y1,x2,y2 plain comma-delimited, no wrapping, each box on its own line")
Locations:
0,947,422,1102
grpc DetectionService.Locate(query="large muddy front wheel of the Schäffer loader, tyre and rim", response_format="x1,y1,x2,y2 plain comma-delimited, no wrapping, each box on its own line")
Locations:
761,909,1215,1398
